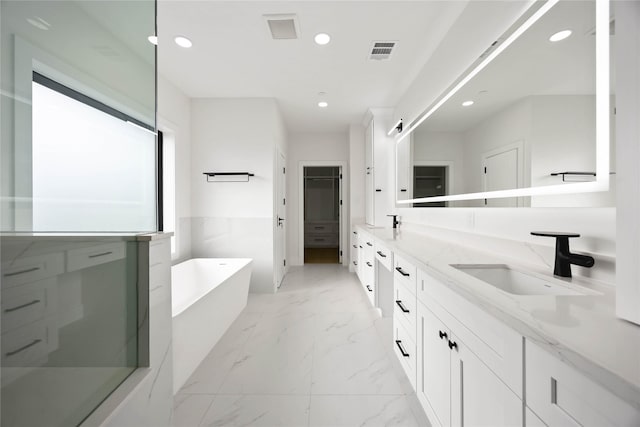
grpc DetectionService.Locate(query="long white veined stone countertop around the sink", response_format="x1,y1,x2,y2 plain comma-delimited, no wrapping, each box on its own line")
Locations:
356,224,640,408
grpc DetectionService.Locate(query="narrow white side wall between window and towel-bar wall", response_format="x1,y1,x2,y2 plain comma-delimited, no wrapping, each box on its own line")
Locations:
158,76,191,262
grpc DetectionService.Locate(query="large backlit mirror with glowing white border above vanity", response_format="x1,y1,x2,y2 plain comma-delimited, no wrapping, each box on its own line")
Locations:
396,0,615,207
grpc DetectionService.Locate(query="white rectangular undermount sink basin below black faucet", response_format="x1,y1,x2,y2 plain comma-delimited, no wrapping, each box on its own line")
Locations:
451,264,599,295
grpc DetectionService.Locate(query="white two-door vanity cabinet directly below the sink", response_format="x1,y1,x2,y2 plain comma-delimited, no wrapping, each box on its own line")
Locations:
416,270,524,426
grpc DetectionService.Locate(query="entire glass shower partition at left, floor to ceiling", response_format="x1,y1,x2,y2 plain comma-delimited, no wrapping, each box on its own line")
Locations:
0,0,158,426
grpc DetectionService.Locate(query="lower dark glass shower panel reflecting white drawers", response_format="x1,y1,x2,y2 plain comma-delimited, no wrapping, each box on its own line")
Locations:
0,235,138,427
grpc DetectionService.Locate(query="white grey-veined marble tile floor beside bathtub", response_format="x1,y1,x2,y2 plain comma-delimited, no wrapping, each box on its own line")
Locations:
174,264,429,427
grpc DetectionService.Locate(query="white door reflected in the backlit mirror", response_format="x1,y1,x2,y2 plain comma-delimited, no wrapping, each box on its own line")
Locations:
483,147,522,207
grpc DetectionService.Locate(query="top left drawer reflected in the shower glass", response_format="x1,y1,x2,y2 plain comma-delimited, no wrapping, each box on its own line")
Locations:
2,252,64,289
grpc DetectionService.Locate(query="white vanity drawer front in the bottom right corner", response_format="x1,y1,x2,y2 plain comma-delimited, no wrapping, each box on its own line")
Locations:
525,341,640,427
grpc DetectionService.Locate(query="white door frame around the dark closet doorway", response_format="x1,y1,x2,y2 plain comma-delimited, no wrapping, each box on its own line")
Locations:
298,160,349,266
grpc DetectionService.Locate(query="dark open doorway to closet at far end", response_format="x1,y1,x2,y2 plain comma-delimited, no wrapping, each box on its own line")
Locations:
303,166,342,264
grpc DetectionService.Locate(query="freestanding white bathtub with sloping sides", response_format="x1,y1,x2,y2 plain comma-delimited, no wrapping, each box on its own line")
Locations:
171,258,252,394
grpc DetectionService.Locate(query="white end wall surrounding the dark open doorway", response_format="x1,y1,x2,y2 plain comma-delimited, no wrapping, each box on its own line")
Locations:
287,132,348,265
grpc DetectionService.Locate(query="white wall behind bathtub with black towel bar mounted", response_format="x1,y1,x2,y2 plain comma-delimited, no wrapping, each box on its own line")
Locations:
190,98,287,292
